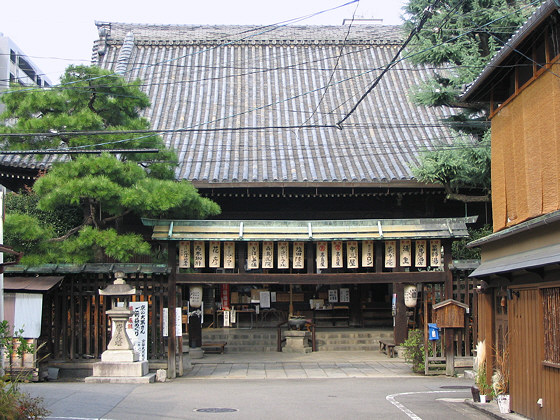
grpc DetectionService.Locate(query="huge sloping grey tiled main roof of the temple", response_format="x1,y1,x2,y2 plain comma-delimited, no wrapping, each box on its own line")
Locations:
1,22,464,187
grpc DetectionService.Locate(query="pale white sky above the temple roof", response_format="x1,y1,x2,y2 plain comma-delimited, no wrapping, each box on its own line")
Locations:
0,0,406,83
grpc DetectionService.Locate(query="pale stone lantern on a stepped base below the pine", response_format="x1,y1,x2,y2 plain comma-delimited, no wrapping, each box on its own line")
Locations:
86,272,155,383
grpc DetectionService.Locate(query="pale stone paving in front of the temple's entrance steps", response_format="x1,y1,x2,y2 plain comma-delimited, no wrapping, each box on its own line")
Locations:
183,352,416,379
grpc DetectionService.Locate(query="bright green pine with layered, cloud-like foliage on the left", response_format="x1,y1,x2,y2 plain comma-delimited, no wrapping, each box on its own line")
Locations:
0,66,220,264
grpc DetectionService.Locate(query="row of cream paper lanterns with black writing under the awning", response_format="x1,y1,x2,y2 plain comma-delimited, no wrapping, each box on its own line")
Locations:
179,239,442,270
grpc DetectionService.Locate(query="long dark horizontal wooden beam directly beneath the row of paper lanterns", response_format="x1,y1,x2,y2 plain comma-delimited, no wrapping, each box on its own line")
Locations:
176,271,446,284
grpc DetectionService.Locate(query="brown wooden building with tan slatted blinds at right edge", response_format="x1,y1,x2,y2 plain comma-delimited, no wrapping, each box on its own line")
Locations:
464,1,560,419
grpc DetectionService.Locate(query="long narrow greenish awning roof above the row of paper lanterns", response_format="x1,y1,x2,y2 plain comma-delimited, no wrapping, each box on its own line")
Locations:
142,217,476,241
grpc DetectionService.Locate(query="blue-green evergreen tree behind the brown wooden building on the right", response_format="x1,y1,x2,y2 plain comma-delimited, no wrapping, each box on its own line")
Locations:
404,0,540,202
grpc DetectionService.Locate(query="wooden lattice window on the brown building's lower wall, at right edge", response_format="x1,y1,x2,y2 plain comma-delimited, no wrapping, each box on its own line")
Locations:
541,287,560,368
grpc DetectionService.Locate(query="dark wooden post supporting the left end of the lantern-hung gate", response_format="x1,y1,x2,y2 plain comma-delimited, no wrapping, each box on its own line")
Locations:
167,241,177,379
